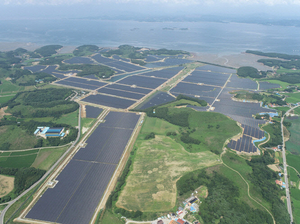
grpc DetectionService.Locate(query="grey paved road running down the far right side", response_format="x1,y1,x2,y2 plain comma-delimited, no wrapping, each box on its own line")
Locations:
281,105,300,223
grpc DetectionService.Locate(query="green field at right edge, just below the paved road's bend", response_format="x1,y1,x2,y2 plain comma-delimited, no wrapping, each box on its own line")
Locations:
286,118,300,155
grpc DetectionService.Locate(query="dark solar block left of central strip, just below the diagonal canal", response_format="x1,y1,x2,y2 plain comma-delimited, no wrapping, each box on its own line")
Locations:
117,75,166,89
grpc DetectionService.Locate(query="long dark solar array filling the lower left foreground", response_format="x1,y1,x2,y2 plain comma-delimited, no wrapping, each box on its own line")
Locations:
26,112,139,224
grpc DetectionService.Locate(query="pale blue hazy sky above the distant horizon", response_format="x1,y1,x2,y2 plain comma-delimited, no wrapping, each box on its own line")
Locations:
0,0,300,19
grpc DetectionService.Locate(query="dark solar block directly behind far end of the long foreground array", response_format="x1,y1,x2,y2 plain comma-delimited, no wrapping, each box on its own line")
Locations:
82,94,136,109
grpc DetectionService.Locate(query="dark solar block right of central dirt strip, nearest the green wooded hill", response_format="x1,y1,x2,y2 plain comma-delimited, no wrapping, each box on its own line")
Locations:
170,82,221,97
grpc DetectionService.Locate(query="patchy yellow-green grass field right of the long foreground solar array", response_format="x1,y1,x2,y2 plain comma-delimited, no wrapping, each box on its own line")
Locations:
117,135,218,212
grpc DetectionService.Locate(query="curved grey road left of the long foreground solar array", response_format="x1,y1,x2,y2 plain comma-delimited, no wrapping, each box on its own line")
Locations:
0,104,81,224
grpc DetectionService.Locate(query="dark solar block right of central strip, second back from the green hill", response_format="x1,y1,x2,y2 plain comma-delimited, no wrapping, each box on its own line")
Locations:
183,71,230,86
